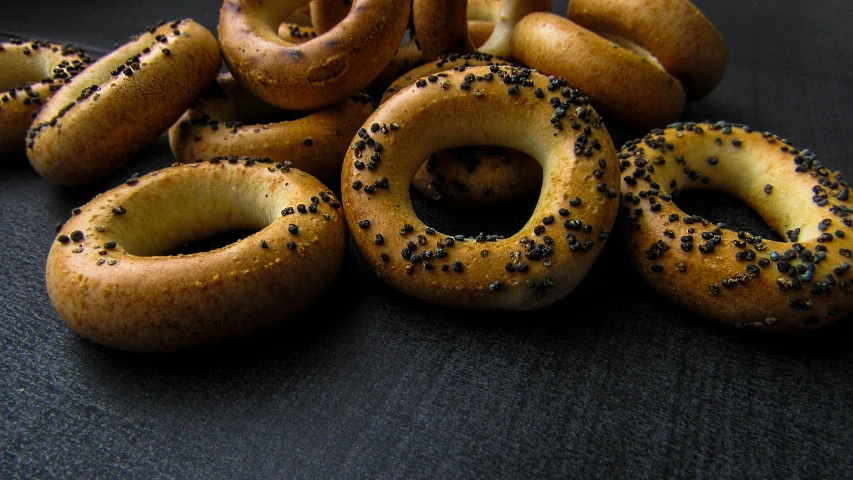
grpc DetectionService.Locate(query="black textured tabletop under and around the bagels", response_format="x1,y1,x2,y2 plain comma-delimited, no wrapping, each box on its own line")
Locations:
0,0,853,478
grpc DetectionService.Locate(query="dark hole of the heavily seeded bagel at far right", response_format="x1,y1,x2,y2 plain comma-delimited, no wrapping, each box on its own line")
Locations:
673,190,787,242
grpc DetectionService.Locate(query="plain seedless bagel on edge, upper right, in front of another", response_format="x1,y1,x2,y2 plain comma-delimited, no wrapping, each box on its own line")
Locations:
512,13,686,128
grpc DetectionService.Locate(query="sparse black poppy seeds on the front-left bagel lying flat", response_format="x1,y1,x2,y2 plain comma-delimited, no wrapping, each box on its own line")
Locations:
56,160,341,266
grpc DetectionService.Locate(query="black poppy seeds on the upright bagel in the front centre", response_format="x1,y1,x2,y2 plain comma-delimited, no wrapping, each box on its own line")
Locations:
351,65,619,297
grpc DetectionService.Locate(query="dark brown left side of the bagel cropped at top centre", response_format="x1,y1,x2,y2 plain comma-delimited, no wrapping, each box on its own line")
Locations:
412,0,474,61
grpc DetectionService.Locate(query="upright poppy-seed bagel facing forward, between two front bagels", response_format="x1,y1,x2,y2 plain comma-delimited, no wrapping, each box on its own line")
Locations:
341,65,619,310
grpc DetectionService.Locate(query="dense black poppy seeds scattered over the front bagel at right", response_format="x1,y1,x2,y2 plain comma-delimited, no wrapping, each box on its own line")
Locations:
618,122,853,327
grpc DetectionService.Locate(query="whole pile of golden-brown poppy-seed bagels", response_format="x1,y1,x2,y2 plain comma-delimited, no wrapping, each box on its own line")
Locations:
0,0,853,351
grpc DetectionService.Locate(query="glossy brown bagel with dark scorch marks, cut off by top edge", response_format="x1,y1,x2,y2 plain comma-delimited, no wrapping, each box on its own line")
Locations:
219,0,410,110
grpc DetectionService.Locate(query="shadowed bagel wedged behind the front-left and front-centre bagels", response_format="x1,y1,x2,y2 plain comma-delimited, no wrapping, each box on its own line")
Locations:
169,73,373,178
